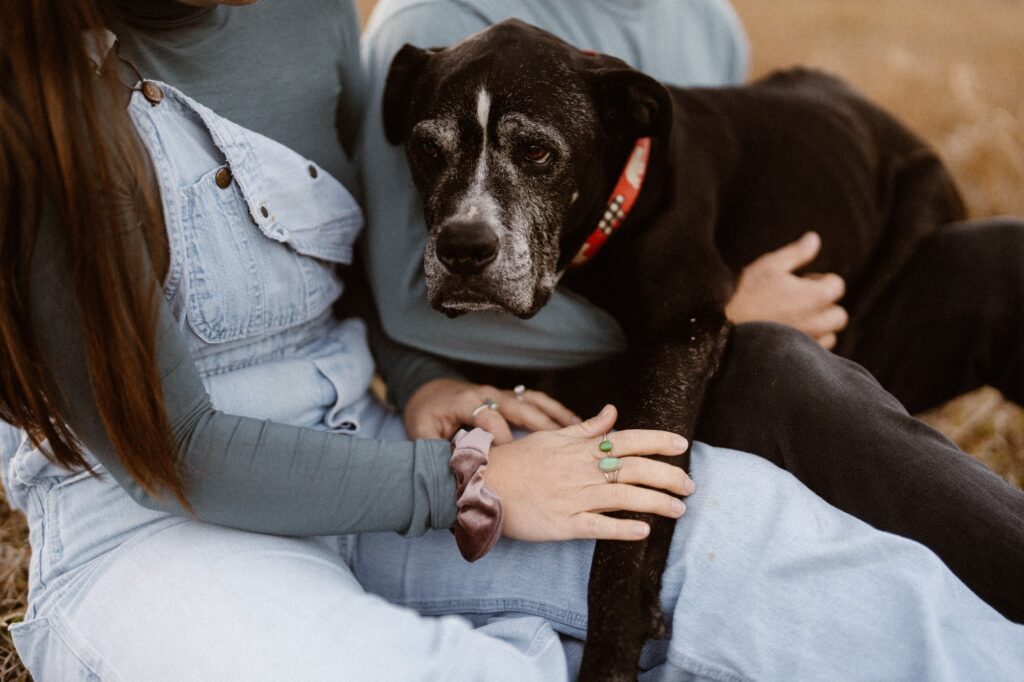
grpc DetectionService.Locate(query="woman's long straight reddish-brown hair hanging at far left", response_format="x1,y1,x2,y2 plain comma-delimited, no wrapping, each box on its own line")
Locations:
0,0,187,506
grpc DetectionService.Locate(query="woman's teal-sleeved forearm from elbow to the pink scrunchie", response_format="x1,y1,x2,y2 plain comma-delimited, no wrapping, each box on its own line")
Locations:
146,317,456,535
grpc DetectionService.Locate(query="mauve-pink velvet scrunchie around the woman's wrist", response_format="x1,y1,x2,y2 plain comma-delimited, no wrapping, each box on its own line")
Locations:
449,429,502,561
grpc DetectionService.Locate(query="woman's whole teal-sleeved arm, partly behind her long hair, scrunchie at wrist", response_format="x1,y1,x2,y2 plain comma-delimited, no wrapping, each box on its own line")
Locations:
31,201,456,535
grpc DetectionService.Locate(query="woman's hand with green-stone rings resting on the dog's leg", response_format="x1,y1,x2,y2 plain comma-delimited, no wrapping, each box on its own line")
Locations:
482,406,694,542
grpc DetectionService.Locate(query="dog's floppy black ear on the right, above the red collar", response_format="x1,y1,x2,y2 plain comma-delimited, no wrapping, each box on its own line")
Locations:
592,63,672,139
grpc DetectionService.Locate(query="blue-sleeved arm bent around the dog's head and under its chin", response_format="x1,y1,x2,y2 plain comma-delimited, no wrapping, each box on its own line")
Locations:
357,4,625,369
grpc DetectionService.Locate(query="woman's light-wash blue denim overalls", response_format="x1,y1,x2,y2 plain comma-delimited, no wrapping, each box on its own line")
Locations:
4,82,1024,682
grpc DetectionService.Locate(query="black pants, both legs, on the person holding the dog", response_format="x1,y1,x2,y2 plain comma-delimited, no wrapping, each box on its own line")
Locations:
696,220,1024,623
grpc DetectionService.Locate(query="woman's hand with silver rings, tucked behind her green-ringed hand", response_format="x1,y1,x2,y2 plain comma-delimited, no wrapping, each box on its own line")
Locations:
402,379,580,444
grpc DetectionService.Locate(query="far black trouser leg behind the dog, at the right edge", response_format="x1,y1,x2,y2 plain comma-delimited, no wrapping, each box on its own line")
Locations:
840,219,1024,413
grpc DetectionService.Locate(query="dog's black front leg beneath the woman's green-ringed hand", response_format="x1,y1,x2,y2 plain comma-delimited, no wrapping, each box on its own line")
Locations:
580,315,729,681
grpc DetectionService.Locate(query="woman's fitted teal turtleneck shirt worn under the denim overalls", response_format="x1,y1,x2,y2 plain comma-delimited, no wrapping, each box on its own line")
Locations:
22,0,456,536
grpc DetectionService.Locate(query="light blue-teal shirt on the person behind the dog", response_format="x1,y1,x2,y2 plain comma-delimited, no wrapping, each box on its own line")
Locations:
356,0,749,369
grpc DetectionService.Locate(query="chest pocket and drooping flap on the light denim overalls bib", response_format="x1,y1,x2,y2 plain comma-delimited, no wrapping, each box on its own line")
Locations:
179,150,361,343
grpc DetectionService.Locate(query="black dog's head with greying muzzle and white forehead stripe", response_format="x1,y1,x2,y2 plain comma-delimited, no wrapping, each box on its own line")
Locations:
384,19,672,317
